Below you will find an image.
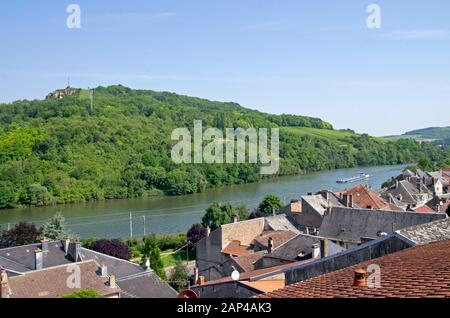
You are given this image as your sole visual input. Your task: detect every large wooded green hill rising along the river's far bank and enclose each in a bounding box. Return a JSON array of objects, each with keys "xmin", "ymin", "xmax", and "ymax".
[{"xmin": 0, "ymin": 86, "xmax": 449, "ymax": 208}]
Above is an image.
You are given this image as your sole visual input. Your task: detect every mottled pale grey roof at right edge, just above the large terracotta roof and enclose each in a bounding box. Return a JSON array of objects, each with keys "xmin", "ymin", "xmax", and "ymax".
[{"xmin": 397, "ymin": 218, "xmax": 450, "ymax": 245}]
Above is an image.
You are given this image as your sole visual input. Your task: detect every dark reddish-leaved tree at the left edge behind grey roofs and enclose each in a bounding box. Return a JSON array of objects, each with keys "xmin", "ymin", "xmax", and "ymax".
[{"xmin": 0, "ymin": 222, "xmax": 42, "ymax": 248}]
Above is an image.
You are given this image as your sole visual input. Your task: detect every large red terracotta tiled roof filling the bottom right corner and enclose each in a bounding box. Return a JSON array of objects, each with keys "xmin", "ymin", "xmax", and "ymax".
[{"xmin": 260, "ymin": 240, "xmax": 450, "ymax": 298}]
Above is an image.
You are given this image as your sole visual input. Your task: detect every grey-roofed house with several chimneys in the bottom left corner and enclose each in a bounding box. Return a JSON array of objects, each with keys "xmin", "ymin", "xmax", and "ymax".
[{"xmin": 0, "ymin": 240, "xmax": 178, "ymax": 298}]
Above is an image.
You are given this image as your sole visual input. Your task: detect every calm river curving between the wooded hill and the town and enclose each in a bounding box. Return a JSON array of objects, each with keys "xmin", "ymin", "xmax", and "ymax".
[{"xmin": 0, "ymin": 165, "xmax": 406, "ymax": 238}]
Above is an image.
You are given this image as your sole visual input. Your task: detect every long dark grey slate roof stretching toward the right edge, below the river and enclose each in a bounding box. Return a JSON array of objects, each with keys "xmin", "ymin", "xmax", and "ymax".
[{"xmin": 319, "ymin": 208, "xmax": 447, "ymax": 244}]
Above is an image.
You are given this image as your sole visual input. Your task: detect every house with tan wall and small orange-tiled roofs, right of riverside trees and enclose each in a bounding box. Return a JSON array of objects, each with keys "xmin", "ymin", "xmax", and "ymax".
[{"xmin": 196, "ymin": 215, "xmax": 299, "ymax": 281}]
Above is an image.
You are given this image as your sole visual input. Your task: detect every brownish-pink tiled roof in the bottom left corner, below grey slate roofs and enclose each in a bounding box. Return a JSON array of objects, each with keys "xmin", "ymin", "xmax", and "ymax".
[{"xmin": 9, "ymin": 261, "xmax": 120, "ymax": 298}]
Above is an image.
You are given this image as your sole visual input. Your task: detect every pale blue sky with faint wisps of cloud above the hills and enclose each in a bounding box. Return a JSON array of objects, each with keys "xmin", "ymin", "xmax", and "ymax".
[{"xmin": 0, "ymin": 0, "xmax": 450, "ymax": 135}]
